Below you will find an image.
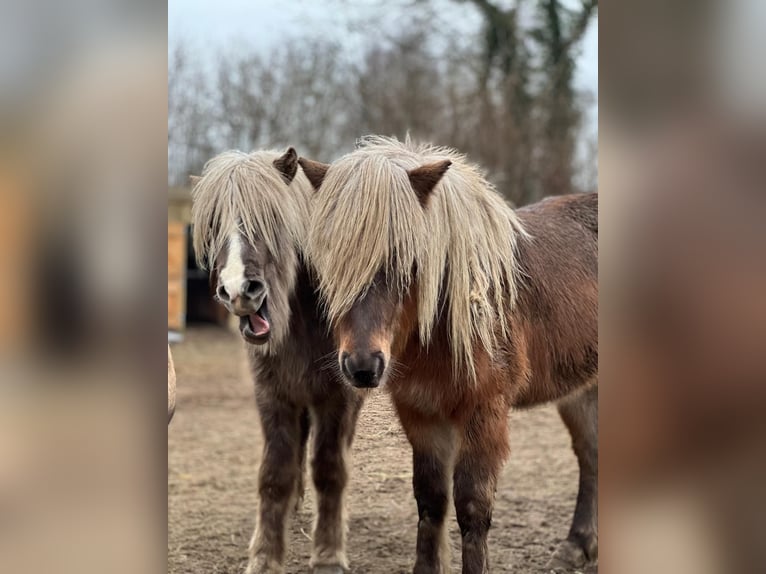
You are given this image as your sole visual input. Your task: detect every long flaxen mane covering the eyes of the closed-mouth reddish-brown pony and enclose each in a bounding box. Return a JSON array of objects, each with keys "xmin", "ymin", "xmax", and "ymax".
[{"xmin": 307, "ymin": 137, "xmax": 526, "ymax": 375}]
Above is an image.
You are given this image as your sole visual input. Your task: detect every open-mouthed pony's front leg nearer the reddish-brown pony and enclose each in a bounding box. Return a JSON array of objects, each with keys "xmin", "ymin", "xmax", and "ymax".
[{"xmin": 310, "ymin": 396, "xmax": 362, "ymax": 574}]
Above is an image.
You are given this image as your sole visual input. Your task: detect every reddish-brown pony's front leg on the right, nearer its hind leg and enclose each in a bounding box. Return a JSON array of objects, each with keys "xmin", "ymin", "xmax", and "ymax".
[{"xmin": 454, "ymin": 402, "xmax": 509, "ymax": 574}]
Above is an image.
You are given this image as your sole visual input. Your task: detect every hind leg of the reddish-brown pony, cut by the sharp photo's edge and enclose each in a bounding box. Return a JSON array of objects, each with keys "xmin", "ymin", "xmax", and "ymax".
[{"xmin": 548, "ymin": 387, "xmax": 598, "ymax": 572}]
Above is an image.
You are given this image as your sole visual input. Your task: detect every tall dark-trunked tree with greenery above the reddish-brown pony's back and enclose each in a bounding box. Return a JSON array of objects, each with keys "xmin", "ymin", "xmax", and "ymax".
[{"xmin": 460, "ymin": 0, "xmax": 597, "ymax": 204}]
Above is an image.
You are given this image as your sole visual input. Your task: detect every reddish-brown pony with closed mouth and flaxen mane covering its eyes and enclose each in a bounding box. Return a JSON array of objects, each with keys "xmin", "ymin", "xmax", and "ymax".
[{"xmin": 299, "ymin": 137, "xmax": 598, "ymax": 574}]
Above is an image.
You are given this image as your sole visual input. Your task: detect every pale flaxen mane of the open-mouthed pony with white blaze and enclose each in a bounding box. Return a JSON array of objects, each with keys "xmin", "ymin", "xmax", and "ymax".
[{"xmin": 192, "ymin": 151, "xmax": 313, "ymax": 268}]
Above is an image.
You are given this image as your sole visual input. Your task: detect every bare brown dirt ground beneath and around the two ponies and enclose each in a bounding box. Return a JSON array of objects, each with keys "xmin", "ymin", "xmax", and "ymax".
[{"xmin": 168, "ymin": 326, "xmax": 597, "ymax": 574}]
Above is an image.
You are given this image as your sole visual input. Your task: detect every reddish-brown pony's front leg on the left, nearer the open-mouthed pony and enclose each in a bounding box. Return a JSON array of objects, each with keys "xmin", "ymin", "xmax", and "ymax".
[{"xmin": 397, "ymin": 405, "xmax": 456, "ymax": 574}]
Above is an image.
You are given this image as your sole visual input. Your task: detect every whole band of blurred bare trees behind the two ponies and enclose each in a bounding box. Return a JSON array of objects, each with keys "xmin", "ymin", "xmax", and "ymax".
[{"xmin": 168, "ymin": 0, "xmax": 597, "ymax": 205}]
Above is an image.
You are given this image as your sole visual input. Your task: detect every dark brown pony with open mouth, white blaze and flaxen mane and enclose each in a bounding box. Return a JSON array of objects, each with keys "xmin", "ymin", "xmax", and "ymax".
[{"xmin": 192, "ymin": 148, "xmax": 362, "ymax": 574}]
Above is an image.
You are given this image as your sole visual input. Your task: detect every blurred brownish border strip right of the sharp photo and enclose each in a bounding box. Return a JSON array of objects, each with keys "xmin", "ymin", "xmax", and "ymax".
[{"xmin": 599, "ymin": 0, "xmax": 766, "ymax": 574}]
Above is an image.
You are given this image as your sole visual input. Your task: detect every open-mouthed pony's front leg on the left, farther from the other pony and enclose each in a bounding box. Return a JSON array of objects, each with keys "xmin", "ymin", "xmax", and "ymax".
[{"xmin": 247, "ymin": 392, "xmax": 301, "ymax": 574}]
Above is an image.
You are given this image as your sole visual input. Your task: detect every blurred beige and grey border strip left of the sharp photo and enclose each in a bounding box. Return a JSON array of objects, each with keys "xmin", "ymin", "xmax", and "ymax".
[{"xmin": 0, "ymin": 0, "xmax": 167, "ymax": 574}]
